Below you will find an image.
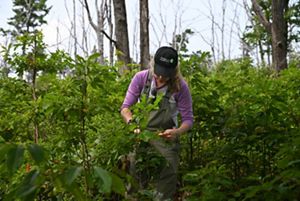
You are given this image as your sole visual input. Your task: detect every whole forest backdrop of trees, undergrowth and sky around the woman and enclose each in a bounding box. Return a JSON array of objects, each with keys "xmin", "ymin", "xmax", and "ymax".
[{"xmin": 0, "ymin": 0, "xmax": 300, "ymax": 200}]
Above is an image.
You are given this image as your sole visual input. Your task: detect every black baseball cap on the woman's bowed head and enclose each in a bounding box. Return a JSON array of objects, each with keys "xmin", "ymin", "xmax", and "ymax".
[{"xmin": 154, "ymin": 46, "xmax": 178, "ymax": 77}]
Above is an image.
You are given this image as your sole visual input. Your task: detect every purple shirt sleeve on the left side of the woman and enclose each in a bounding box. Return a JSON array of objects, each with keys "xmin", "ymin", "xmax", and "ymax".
[{"xmin": 121, "ymin": 71, "xmax": 145, "ymax": 110}]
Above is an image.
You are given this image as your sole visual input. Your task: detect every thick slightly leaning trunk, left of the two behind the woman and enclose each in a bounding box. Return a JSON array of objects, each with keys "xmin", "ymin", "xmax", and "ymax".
[{"xmin": 113, "ymin": 0, "xmax": 130, "ymax": 73}]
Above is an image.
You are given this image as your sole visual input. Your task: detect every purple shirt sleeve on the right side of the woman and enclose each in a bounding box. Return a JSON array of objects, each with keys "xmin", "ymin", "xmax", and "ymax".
[{"xmin": 177, "ymin": 80, "xmax": 194, "ymax": 127}]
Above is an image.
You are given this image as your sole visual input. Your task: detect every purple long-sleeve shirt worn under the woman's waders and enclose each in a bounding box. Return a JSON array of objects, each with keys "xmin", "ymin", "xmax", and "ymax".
[{"xmin": 121, "ymin": 70, "xmax": 194, "ymax": 127}]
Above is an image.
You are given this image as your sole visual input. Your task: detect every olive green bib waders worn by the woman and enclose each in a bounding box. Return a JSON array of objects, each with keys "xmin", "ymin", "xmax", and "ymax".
[{"xmin": 131, "ymin": 72, "xmax": 179, "ymax": 200}]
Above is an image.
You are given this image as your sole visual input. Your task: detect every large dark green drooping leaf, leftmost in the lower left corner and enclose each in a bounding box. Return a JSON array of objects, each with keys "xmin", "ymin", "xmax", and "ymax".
[{"xmin": 6, "ymin": 145, "xmax": 24, "ymax": 174}]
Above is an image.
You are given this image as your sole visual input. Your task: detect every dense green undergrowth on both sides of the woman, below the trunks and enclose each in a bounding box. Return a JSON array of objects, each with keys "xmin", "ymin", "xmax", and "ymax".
[{"xmin": 0, "ymin": 47, "xmax": 300, "ymax": 200}]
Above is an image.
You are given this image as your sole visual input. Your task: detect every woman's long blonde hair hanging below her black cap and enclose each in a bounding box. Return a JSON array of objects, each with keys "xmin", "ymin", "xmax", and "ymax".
[{"xmin": 149, "ymin": 59, "xmax": 182, "ymax": 93}]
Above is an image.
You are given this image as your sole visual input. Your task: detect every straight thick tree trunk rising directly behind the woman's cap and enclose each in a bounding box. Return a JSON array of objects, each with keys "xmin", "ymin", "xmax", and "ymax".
[{"xmin": 140, "ymin": 0, "xmax": 150, "ymax": 70}]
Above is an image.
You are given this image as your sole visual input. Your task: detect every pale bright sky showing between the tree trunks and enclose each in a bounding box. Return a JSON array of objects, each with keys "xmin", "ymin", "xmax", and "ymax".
[{"xmin": 0, "ymin": 0, "xmax": 248, "ymax": 61}]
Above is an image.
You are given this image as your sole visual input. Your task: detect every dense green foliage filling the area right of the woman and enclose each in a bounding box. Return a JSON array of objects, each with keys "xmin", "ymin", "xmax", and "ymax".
[{"xmin": 179, "ymin": 57, "xmax": 300, "ymax": 200}]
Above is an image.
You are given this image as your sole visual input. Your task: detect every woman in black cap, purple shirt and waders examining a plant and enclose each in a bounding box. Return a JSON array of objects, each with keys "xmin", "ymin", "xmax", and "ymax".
[{"xmin": 121, "ymin": 46, "xmax": 193, "ymax": 199}]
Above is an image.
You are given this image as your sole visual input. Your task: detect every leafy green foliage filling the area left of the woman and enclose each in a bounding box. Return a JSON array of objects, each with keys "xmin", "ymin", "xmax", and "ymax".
[{"xmin": 0, "ymin": 51, "xmax": 125, "ymax": 200}]
